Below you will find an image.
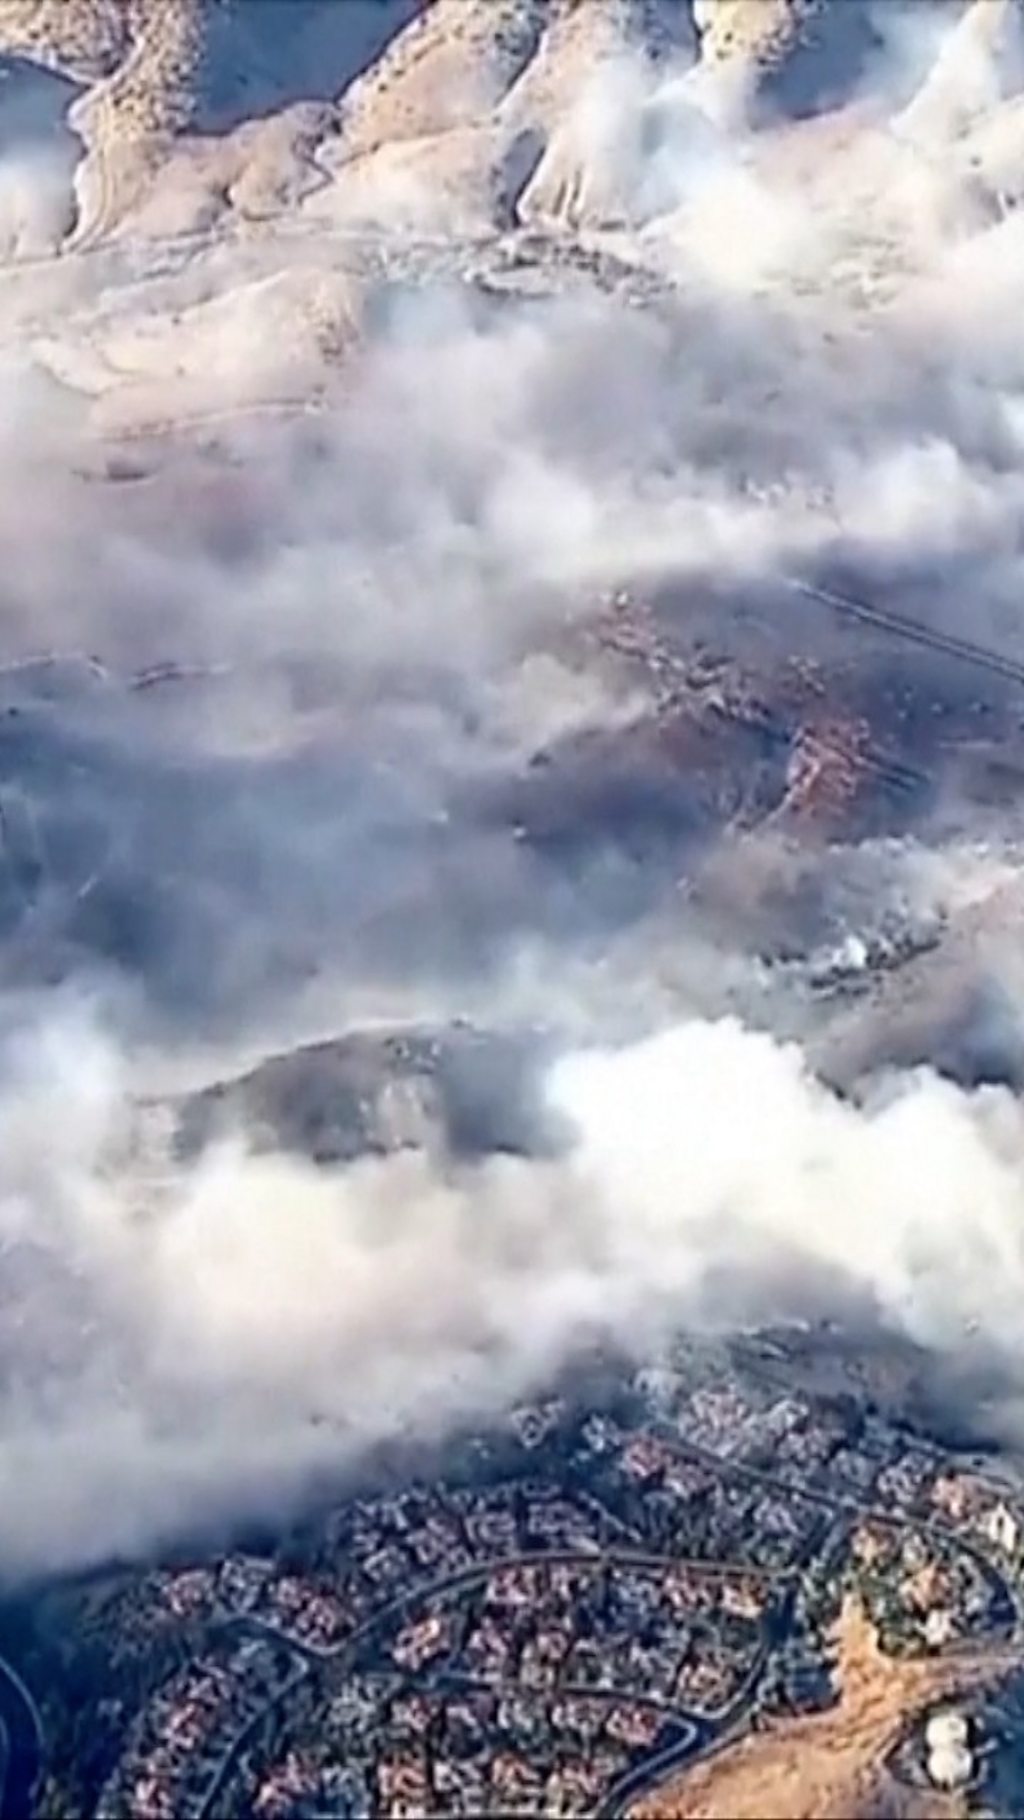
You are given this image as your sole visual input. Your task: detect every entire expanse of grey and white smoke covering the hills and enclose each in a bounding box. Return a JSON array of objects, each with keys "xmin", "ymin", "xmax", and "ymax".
[{"xmin": 0, "ymin": 7, "xmax": 1024, "ymax": 1572}]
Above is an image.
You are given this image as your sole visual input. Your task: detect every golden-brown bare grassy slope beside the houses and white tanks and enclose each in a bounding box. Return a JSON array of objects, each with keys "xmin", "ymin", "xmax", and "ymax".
[{"xmin": 633, "ymin": 1600, "xmax": 1011, "ymax": 1820}]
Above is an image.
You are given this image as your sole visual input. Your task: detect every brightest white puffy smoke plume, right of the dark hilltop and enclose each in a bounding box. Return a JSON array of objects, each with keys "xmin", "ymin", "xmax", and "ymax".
[{"xmin": 553, "ymin": 1023, "xmax": 1024, "ymax": 1347}]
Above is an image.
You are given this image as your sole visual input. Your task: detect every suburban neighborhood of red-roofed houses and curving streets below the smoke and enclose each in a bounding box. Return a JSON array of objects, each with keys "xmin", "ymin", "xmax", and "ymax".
[{"xmin": 6, "ymin": 1343, "xmax": 1024, "ymax": 1820}]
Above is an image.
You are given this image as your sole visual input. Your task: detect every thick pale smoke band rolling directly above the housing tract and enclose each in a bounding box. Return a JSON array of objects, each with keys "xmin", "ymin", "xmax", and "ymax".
[{"xmin": 0, "ymin": 1019, "xmax": 1024, "ymax": 1569}]
